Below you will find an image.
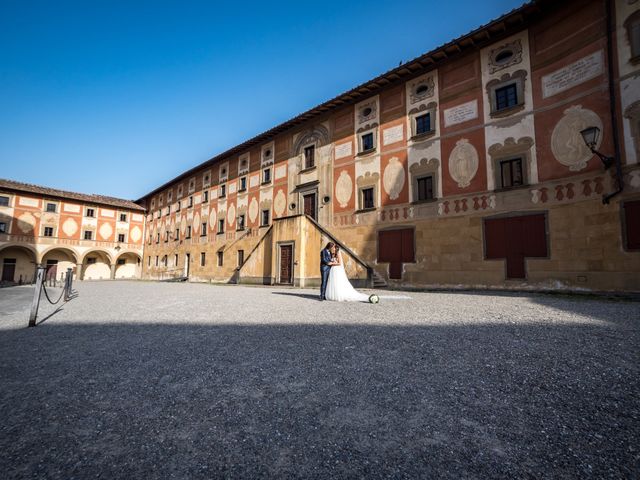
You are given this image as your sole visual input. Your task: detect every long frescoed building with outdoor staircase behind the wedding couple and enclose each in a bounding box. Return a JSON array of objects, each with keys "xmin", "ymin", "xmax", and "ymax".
[{"xmin": 1, "ymin": 0, "xmax": 640, "ymax": 290}]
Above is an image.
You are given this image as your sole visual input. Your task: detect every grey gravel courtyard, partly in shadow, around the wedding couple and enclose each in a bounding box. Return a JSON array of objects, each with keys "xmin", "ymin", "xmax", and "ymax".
[{"xmin": 0, "ymin": 282, "xmax": 640, "ymax": 479}]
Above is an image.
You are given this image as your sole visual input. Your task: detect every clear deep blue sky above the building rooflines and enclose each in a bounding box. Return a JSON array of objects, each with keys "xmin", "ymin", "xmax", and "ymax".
[{"xmin": 0, "ymin": 0, "xmax": 522, "ymax": 199}]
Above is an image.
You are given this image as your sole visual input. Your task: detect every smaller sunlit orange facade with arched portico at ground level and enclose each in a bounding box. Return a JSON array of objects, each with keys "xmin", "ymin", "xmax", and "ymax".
[{"xmin": 0, "ymin": 180, "xmax": 145, "ymax": 283}]
